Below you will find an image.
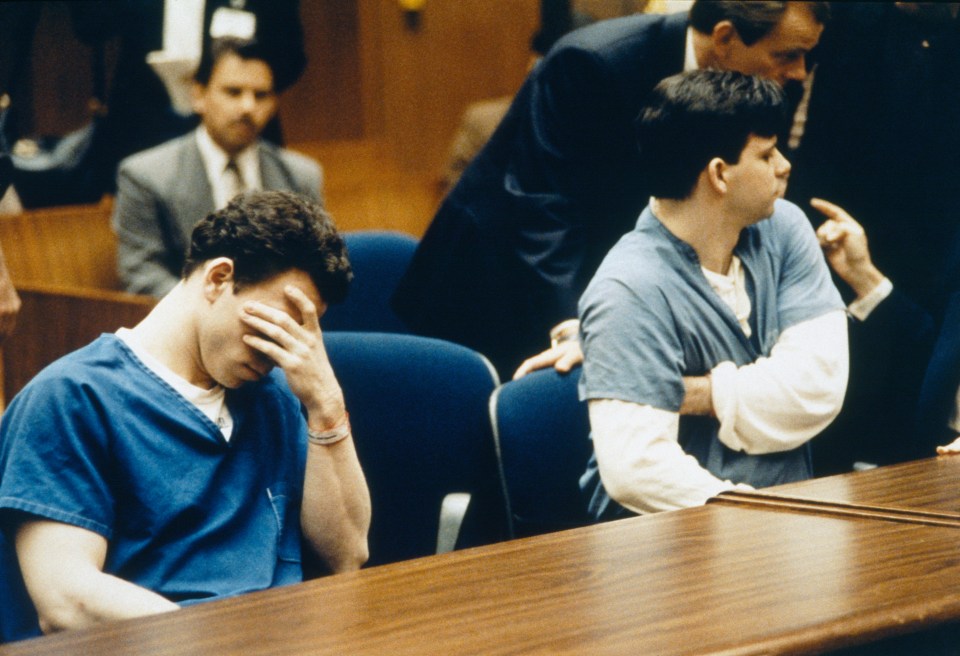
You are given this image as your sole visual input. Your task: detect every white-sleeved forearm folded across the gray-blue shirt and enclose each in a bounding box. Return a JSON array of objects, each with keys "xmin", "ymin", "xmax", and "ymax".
[{"xmin": 711, "ymin": 311, "xmax": 849, "ymax": 454}]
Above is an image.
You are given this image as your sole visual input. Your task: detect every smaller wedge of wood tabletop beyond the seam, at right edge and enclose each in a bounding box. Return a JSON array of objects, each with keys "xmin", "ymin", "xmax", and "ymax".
[{"xmin": 715, "ymin": 456, "xmax": 960, "ymax": 528}]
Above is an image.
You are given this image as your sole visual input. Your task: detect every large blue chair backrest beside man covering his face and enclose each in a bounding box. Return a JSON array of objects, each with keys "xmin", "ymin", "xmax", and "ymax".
[{"xmin": 324, "ymin": 332, "xmax": 507, "ymax": 565}]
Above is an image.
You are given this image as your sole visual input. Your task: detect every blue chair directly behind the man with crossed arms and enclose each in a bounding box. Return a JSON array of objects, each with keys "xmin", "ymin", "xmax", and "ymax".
[{"xmin": 490, "ymin": 368, "xmax": 593, "ymax": 537}]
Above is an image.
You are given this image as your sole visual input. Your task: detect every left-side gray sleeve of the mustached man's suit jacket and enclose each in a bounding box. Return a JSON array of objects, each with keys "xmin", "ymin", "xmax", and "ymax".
[{"xmin": 113, "ymin": 164, "xmax": 180, "ymax": 297}]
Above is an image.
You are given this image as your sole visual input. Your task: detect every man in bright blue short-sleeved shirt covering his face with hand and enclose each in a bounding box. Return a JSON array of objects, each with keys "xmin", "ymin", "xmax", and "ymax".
[{"xmin": 0, "ymin": 192, "xmax": 370, "ymax": 632}]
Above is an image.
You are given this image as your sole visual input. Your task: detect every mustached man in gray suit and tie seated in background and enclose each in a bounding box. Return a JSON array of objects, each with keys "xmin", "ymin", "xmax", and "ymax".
[{"xmin": 113, "ymin": 39, "xmax": 322, "ymax": 297}]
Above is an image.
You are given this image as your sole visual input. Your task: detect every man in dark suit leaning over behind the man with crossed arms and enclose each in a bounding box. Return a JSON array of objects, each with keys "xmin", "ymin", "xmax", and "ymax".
[{"xmin": 394, "ymin": 2, "xmax": 826, "ymax": 376}]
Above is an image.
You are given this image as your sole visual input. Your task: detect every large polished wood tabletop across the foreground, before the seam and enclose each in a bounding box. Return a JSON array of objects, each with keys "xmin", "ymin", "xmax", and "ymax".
[{"xmin": 0, "ymin": 504, "xmax": 960, "ymax": 656}]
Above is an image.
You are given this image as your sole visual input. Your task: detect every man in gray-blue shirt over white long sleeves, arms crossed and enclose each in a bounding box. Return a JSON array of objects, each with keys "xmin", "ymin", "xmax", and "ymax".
[{"xmin": 580, "ymin": 71, "xmax": 847, "ymax": 519}]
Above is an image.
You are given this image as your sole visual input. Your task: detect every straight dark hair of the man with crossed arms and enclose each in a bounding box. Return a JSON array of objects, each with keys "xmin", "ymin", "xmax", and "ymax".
[{"xmin": 636, "ymin": 70, "xmax": 788, "ymax": 200}]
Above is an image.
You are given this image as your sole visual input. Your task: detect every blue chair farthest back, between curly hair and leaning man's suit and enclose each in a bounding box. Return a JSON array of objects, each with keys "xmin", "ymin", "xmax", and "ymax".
[{"xmin": 320, "ymin": 230, "xmax": 417, "ymax": 333}]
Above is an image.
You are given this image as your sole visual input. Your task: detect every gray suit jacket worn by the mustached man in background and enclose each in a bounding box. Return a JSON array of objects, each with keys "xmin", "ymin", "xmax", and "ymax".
[{"xmin": 113, "ymin": 132, "xmax": 323, "ymax": 296}]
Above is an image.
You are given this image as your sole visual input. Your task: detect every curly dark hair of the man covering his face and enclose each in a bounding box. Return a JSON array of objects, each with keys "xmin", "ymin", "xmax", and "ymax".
[{"xmin": 183, "ymin": 191, "xmax": 353, "ymax": 303}]
